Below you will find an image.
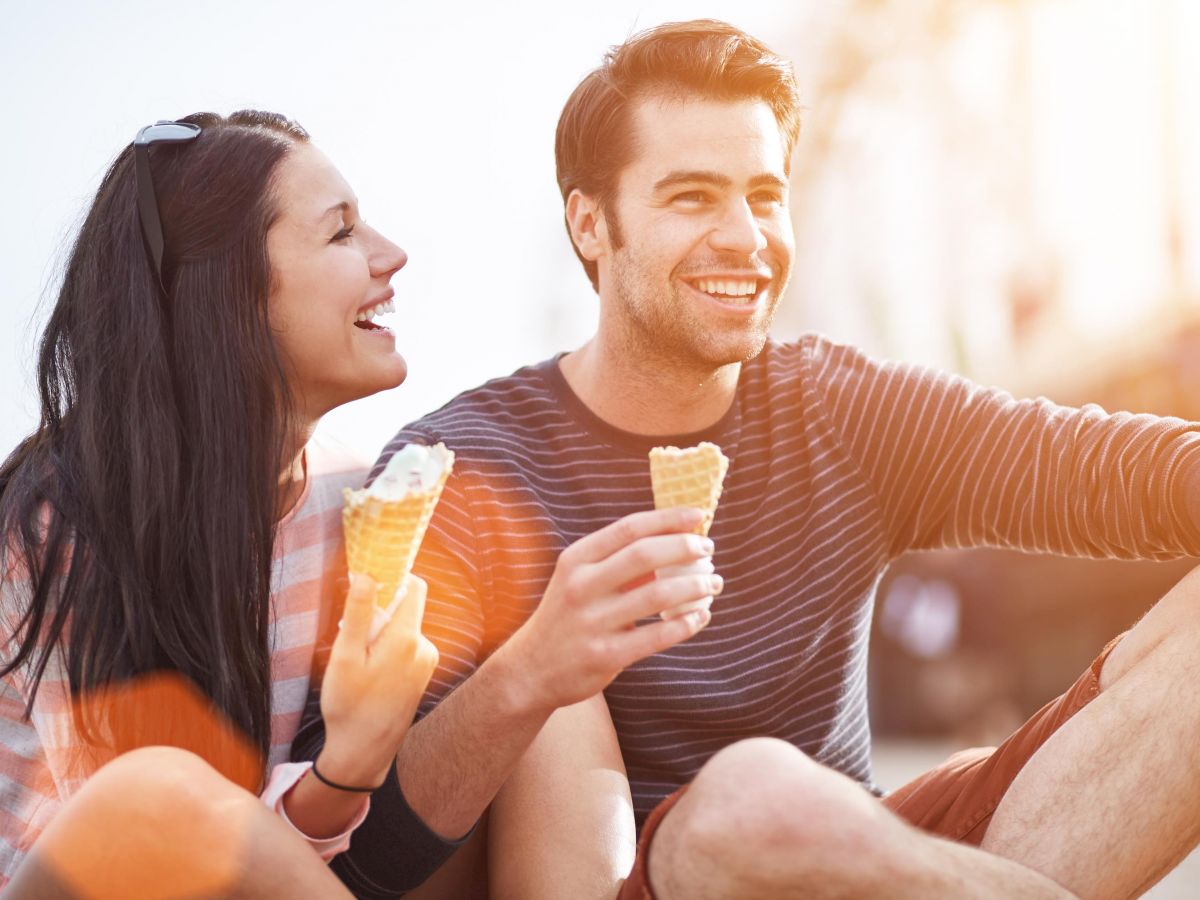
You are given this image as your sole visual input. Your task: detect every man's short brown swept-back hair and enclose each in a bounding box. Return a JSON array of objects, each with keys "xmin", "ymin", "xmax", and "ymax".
[{"xmin": 554, "ymin": 19, "xmax": 800, "ymax": 290}]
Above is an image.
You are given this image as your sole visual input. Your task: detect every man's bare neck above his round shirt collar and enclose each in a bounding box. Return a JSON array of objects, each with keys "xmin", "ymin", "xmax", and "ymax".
[{"xmin": 558, "ymin": 335, "xmax": 742, "ymax": 436}]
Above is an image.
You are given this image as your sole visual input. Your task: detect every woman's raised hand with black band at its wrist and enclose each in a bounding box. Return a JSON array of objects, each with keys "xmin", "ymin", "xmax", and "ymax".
[{"xmin": 317, "ymin": 572, "xmax": 438, "ymax": 787}]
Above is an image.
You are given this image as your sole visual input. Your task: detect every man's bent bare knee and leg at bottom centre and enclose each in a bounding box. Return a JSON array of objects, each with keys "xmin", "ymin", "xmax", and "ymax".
[{"xmin": 649, "ymin": 738, "xmax": 1070, "ymax": 900}]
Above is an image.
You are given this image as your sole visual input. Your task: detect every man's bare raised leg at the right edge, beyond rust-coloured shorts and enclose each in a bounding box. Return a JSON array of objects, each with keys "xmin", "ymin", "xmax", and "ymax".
[{"xmin": 983, "ymin": 570, "xmax": 1200, "ymax": 898}]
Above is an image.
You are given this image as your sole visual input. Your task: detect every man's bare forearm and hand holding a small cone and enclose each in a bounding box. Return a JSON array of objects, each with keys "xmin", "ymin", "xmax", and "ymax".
[{"xmin": 396, "ymin": 510, "xmax": 722, "ymax": 839}]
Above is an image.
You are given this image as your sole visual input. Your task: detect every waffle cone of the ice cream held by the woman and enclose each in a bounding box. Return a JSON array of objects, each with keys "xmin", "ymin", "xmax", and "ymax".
[{"xmin": 342, "ymin": 457, "xmax": 452, "ymax": 608}]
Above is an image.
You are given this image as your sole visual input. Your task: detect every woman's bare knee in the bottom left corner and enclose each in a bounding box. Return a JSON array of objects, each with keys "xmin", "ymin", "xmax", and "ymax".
[{"xmin": 5, "ymin": 748, "xmax": 349, "ymax": 900}]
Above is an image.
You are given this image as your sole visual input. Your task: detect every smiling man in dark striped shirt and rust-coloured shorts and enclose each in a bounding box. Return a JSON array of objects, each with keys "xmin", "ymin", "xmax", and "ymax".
[{"xmin": 297, "ymin": 15, "xmax": 1200, "ymax": 900}]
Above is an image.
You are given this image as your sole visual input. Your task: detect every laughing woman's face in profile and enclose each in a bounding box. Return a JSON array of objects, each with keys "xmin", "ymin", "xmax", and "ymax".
[{"xmin": 266, "ymin": 143, "xmax": 408, "ymax": 421}]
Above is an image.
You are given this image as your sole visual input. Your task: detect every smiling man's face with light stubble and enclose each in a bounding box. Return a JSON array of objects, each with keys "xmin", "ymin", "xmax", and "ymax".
[{"xmin": 598, "ymin": 97, "xmax": 794, "ymax": 367}]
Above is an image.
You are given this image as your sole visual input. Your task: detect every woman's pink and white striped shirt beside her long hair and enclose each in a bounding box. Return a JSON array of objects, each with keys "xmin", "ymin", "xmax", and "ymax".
[{"xmin": 0, "ymin": 439, "xmax": 366, "ymax": 887}]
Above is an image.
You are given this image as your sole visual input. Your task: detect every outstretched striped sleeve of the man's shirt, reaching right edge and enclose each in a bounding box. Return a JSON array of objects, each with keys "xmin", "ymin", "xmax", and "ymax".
[{"xmin": 808, "ymin": 342, "xmax": 1200, "ymax": 559}]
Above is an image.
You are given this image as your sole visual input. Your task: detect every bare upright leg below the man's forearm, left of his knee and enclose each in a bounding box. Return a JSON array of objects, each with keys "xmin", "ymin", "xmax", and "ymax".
[{"xmin": 488, "ymin": 694, "xmax": 637, "ymax": 900}]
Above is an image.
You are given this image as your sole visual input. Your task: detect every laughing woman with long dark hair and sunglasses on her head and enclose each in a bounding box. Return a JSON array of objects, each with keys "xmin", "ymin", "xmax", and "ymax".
[{"xmin": 0, "ymin": 112, "xmax": 436, "ymax": 898}]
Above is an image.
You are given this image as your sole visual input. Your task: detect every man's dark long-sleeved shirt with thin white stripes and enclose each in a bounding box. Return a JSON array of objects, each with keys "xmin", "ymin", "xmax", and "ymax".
[{"xmin": 374, "ymin": 335, "xmax": 1200, "ymax": 827}]
